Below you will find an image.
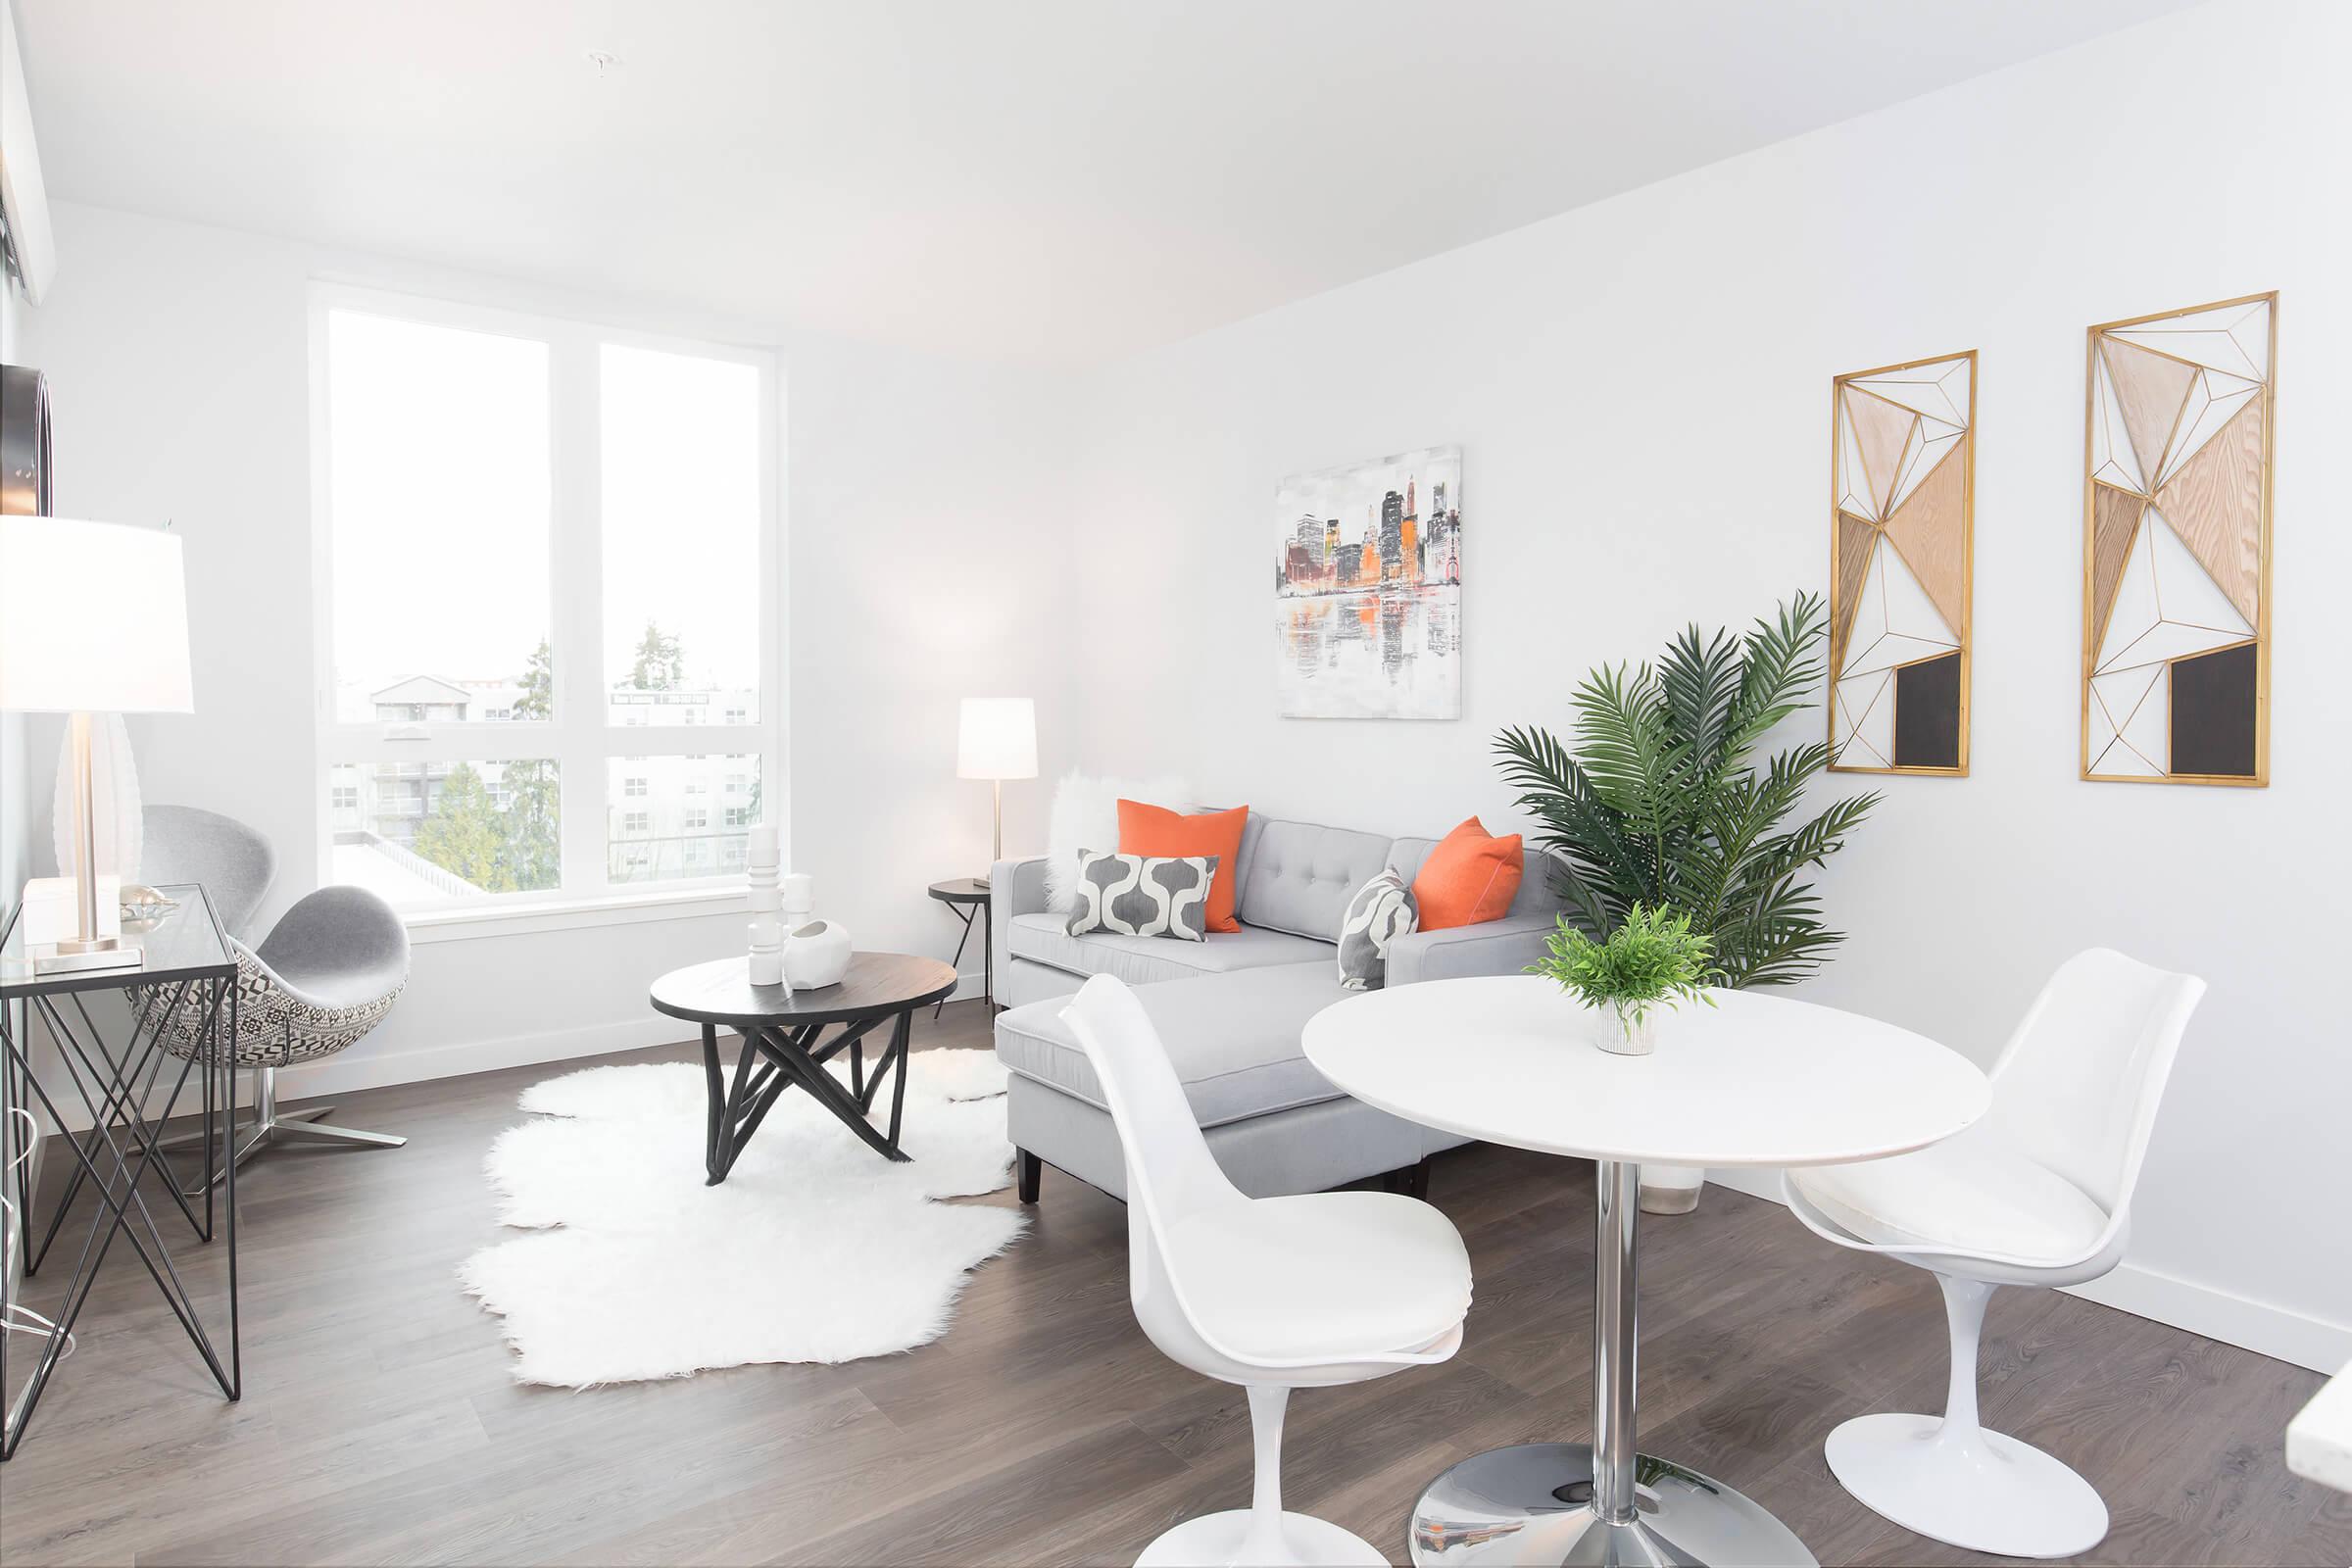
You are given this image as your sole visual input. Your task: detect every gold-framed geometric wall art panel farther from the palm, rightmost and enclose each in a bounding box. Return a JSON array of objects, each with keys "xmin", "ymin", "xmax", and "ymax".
[{"xmin": 2082, "ymin": 294, "xmax": 2279, "ymax": 785}]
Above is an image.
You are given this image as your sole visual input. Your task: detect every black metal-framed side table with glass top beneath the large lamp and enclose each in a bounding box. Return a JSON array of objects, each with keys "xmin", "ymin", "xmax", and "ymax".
[{"xmin": 0, "ymin": 884, "xmax": 245, "ymax": 1460}]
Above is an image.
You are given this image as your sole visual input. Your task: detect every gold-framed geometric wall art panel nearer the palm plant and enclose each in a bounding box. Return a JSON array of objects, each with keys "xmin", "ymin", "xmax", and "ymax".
[{"xmin": 1828, "ymin": 348, "xmax": 1976, "ymax": 778}]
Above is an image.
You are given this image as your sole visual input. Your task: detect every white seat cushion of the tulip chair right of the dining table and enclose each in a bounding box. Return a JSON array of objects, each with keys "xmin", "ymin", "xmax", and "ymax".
[{"xmin": 1788, "ymin": 1124, "xmax": 2107, "ymax": 1265}]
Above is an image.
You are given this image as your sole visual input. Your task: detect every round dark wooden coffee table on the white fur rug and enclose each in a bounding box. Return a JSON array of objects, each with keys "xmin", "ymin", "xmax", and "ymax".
[{"xmin": 654, "ymin": 953, "xmax": 955, "ymax": 1187}]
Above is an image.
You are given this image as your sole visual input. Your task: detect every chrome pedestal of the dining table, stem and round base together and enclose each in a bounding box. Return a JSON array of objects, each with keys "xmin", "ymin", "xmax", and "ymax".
[{"xmin": 1411, "ymin": 1159, "xmax": 1816, "ymax": 1568}]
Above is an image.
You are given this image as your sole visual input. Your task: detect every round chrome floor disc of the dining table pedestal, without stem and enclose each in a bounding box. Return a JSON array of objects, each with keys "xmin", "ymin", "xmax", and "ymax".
[{"xmin": 1411, "ymin": 1444, "xmax": 1813, "ymax": 1568}]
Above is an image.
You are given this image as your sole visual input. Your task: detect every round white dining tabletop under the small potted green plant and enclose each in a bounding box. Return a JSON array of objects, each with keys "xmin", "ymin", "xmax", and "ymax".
[{"xmin": 1303, "ymin": 976, "xmax": 1992, "ymax": 1166}]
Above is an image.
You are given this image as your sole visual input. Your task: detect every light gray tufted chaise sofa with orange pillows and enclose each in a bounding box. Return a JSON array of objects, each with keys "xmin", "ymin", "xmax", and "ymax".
[{"xmin": 990, "ymin": 815, "xmax": 1559, "ymax": 1201}]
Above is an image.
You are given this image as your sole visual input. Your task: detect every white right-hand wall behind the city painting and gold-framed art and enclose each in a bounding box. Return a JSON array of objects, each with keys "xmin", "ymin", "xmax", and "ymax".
[{"xmin": 1075, "ymin": 0, "xmax": 2352, "ymax": 1366}]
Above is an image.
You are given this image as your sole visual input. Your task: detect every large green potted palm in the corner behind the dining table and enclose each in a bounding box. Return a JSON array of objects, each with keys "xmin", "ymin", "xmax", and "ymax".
[{"xmin": 1495, "ymin": 592, "xmax": 1880, "ymax": 1213}]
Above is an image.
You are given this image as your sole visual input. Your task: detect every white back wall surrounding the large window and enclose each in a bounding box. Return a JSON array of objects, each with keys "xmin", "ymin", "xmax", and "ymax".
[{"xmin": 24, "ymin": 202, "xmax": 1070, "ymax": 1091}]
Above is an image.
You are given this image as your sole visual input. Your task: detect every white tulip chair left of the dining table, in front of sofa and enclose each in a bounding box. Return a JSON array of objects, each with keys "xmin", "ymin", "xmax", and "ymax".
[{"xmin": 1065, "ymin": 976, "xmax": 1470, "ymax": 1568}]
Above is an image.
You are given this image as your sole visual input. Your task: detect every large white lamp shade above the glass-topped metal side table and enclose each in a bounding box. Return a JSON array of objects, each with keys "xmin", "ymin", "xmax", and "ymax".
[{"xmin": 0, "ymin": 514, "xmax": 195, "ymax": 712}]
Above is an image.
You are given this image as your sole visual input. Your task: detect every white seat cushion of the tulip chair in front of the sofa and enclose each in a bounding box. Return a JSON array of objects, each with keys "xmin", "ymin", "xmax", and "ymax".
[{"xmin": 1159, "ymin": 1192, "xmax": 1470, "ymax": 1361}]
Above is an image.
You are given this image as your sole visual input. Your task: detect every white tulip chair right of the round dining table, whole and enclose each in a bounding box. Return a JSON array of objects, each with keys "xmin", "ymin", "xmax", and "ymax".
[{"xmin": 1783, "ymin": 948, "xmax": 2206, "ymax": 1556}]
